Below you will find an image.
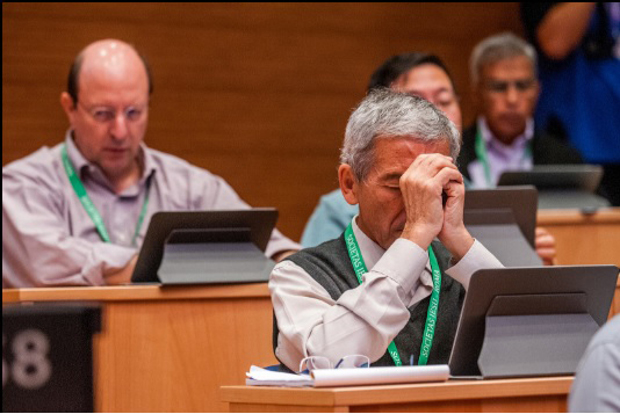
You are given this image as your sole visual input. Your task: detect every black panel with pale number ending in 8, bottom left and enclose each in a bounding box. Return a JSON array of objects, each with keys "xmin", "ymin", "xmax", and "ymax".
[{"xmin": 2, "ymin": 304, "xmax": 101, "ymax": 412}]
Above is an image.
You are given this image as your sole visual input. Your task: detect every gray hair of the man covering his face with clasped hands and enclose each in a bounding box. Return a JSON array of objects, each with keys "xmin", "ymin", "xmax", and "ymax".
[{"xmin": 340, "ymin": 88, "xmax": 461, "ymax": 181}]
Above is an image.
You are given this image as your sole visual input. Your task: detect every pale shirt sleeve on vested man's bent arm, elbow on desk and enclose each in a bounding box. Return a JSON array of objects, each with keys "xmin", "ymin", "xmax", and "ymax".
[{"xmin": 269, "ymin": 239, "xmax": 427, "ymax": 371}]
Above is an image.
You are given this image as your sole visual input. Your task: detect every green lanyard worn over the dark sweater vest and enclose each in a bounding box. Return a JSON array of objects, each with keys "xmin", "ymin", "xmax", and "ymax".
[{"xmin": 344, "ymin": 223, "xmax": 441, "ymax": 367}]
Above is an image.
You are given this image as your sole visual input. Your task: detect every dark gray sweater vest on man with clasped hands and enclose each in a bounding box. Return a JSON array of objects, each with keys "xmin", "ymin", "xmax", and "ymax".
[{"xmin": 273, "ymin": 235, "xmax": 465, "ymax": 366}]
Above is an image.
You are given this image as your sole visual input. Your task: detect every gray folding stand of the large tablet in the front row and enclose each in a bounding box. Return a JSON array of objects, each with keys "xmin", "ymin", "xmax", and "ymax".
[{"xmin": 478, "ymin": 293, "xmax": 599, "ymax": 378}]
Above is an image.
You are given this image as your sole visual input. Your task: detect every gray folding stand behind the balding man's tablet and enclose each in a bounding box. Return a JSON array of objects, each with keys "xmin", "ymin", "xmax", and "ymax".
[{"xmin": 157, "ymin": 227, "xmax": 275, "ymax": 285}]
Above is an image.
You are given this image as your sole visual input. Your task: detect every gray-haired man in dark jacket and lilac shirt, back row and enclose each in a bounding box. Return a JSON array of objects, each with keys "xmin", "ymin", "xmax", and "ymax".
[{"xmin": 458, "ymin": 33, "xmax": 582, "ymax": 191}]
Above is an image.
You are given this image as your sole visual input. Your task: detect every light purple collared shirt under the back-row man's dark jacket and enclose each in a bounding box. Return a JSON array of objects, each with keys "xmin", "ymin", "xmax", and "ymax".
[{"xmin": 467, "ymin": 117, "xmax": 534, "ymax": 188}]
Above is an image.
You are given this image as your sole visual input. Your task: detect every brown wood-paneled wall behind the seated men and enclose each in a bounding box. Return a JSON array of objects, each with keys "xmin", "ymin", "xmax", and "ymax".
[{"xmin": 2, "ymin": 3, "xmax": 522, "ymax": 239}]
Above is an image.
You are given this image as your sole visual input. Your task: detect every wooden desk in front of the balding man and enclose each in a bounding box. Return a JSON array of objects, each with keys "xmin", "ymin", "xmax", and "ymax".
[{"xmin": 2, "ymin": 284, "xmax": 276, "ymax": 412}]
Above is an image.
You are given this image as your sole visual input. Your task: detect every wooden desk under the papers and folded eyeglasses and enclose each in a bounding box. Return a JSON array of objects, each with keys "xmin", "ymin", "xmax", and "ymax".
[{"xmin": 220, "ymin": 377, "xmax": 573, "ymax": 412}]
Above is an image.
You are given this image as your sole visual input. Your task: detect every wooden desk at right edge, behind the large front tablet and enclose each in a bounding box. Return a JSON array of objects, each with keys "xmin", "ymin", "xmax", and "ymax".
[{"xmin": 537, "ymin": 208, "xmax": 620, "ymax": 315}]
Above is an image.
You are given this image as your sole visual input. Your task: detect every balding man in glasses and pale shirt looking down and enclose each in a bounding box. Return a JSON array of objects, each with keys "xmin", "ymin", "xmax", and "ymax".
[{"xmin": 2, "ymin": 39, "xmax": 298, "ymax": 287}]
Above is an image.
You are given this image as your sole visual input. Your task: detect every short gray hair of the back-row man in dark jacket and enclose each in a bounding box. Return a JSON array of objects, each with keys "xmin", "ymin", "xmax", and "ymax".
[{"xmin": 469, "ymin": 32, "xmax": 538, "ymax": 85}]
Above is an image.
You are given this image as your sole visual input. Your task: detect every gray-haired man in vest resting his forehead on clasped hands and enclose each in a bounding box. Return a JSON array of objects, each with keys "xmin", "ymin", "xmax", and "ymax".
[{"xmin": 269, "ymin": 89, "xmax": 501, "ymax": 371}]
